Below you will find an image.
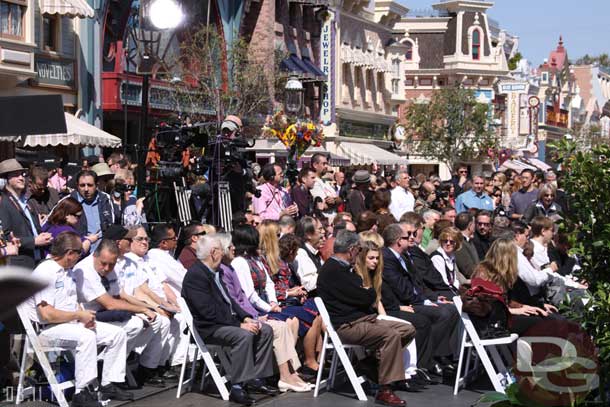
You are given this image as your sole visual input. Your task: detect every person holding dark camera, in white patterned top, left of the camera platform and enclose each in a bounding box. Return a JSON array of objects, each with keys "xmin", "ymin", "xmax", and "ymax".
[{"xmin": 107, "ymin": 169, "xmax": 146, "ymax": 226}]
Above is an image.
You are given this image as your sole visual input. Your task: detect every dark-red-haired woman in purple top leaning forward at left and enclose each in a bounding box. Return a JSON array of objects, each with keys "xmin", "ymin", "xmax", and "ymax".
[{"xmin": 42, "ymin": 197, "xmax": 99, "ymax": 253}]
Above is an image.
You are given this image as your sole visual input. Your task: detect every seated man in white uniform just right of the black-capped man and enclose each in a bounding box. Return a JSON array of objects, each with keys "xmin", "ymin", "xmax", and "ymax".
[{"xmin": 125, "ymin": 226, "xmax": 181, "ymax": 380}]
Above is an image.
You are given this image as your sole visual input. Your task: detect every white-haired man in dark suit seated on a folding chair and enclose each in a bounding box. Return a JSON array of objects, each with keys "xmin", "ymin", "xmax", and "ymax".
[{"xmin": 182, "ymin": 235, "xmax": 277, "ymax": 405}]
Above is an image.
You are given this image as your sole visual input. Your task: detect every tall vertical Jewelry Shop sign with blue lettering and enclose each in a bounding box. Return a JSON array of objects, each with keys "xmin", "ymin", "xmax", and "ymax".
[{"xmin": 320, "ymin": 10, "xmax": 334, "ymax": 125}]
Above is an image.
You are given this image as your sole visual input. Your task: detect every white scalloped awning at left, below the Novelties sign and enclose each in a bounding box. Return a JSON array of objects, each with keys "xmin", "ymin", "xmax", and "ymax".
[{"xmin": 12, "ymin": 113, "xmax": 121, "ymax": 147}]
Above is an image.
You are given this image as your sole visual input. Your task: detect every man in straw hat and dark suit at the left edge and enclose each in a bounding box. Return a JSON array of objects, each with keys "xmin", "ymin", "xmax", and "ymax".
[{"xmin": 0, "ymin": 158, "xmax": 53, "ymax": 269}]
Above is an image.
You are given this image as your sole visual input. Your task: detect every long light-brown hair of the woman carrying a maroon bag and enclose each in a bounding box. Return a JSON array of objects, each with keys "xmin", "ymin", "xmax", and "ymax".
[{"xmin": 474, "ymin": 237, "xmax": 519, "ymax": 291}]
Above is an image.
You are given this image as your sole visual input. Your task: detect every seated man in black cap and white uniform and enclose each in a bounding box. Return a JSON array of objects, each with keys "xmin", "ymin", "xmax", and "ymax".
[{"xmin": 104, "ymin": 225, "xmax": 170, "ymax": 386}]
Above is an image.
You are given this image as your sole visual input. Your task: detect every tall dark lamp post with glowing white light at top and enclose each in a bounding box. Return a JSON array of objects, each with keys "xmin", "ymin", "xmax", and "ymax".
[{"xmin": 137, "ymin": 0, "xmax": 184, "ymax": 197}]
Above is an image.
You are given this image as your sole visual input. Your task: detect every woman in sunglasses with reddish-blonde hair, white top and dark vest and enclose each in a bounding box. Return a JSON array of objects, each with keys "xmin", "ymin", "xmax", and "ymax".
[{"xmin": 430, "ymin": 226, "xmax": 465, "ymax": 298}]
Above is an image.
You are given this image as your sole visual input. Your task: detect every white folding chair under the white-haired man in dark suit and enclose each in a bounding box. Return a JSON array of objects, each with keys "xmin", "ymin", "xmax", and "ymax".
[{"xmin": 176, "ymin": 297, "xmax": 229, "ymax": 401}]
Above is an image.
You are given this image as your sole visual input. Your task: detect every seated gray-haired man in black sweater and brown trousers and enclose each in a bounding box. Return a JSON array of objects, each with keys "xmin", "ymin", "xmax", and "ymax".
[{"xmin": 317, "ymin": 230, "xmax": 415, "ymax": 406}]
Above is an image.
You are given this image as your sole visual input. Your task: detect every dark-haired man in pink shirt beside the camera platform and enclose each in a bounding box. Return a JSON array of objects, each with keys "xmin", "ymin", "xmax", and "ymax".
[{"xmin": 252, "ymin": 164, "xmax": 299, "ymax": 221}]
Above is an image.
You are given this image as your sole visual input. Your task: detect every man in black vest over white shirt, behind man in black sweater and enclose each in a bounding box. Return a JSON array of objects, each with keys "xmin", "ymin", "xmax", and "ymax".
[{"xmin": 295, "ymin": 216, "xmax": 326, "ymax": 292}]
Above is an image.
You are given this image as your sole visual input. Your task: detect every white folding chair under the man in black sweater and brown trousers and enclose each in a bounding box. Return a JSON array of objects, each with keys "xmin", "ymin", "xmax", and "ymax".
[{"xmin": 313, "ymin": 297, "xmax": 367, "ymax": 401}]
